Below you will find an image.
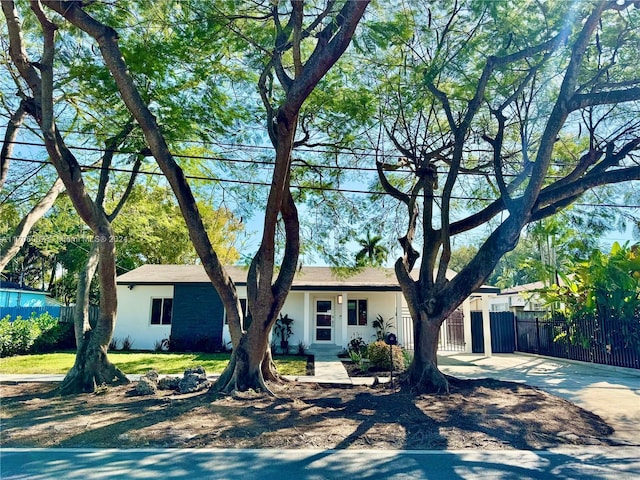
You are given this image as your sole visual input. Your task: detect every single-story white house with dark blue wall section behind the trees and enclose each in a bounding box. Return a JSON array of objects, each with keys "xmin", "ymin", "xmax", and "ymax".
[{"xmin": 114, "ymin": 265, "xmax": 498, "ymax": 351}]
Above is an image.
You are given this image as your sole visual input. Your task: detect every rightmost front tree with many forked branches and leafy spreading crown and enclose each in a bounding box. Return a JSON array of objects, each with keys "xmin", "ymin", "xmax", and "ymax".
[{"xmin": 371, "ymin": 1, "xmax": 640, "ymax": 391}]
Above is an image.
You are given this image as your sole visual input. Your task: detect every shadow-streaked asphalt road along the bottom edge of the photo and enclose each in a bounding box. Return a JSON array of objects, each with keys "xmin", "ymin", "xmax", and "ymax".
[{"xmin": 0, "ymin": 447, "xmax": 640, "ymax": 480}]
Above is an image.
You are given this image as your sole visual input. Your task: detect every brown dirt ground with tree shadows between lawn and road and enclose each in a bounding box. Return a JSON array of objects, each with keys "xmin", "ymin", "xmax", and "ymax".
[{"xmin": 0, "ymin": 380, "xmax": 612, "ymax": 449}]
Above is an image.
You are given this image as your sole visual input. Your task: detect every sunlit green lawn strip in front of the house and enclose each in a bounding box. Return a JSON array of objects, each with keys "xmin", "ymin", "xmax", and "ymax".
[{"xmin": 0, "ymin": 352, "xmax": 307, "ymax": 375}]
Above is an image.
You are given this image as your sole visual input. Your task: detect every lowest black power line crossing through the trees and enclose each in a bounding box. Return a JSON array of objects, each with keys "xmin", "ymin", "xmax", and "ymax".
[{"xmin": 7, "ymin": 157, "xmax": 640, "ymax": 209}]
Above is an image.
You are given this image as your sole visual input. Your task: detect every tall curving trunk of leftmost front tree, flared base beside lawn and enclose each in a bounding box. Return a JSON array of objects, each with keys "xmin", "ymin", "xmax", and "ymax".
[{"xmin": 2, "ymin": 1, "xmax": 129, "ymax": 394}]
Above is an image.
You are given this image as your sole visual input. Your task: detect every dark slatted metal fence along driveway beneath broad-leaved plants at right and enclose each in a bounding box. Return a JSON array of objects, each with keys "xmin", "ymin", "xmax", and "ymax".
[{"xmin": 516, "ymin": 314, "xmax": 640, "ymax": 369}]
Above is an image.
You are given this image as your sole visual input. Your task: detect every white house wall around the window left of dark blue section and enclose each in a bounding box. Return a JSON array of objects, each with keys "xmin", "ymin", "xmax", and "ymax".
[{"xmin": 113, "ymin": 285, "xmax": 173, "ymax": 350}]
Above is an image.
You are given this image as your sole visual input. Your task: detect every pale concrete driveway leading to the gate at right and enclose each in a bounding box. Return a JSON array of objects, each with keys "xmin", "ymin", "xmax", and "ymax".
[{"xmin": 439, "ymin": 354, "xmax": 640, "ymax": 445}]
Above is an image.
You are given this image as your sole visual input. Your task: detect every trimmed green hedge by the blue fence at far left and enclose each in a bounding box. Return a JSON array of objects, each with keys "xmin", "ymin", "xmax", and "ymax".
[{"xmin": 0, "ymin": 312, "xmax": 75, "ymax": 357}]
